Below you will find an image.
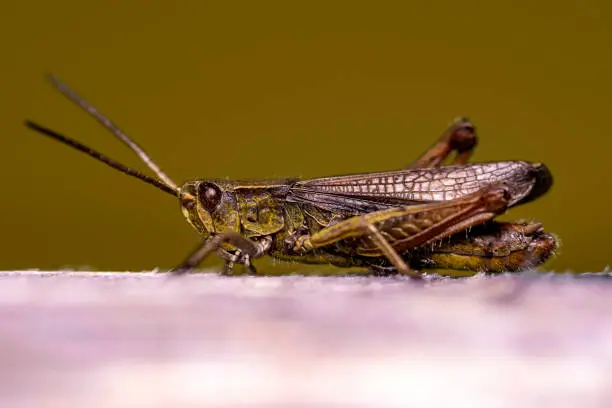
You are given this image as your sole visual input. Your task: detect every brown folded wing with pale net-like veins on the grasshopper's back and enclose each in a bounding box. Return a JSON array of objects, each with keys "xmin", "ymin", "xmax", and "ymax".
[{"xmin": 287, "ymin": 161, "xmax": 550, "ymax": 215}]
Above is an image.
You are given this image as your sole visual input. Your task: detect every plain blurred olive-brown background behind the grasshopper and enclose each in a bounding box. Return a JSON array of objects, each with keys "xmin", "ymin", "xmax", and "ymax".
[{"xmin": 0, "ymin": 0, "xmax": 612, "ymax": 271}]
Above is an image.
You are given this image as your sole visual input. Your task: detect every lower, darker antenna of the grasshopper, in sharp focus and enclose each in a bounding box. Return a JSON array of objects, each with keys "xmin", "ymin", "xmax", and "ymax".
[{"xmin": 25, "ymin": 120, "xmax": 180, "ymax": 197}]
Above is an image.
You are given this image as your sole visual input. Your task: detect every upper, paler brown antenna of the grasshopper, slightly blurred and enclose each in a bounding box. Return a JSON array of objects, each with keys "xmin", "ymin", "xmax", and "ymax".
[{"xmin": 47, "ymin": 74, "xmax": 178, "ymax": 190}]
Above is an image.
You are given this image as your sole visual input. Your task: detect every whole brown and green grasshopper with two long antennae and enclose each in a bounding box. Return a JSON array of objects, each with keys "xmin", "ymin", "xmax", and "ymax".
[{"xmin": 25, "ymin": 76, "xmax": 557, "ymax": 278}]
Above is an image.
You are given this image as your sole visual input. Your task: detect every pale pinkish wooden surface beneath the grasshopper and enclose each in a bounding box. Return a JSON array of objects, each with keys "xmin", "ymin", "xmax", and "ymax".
[{"xmin": 0, "ymin": 272, "xmax": 612, "ymax": 408}]
